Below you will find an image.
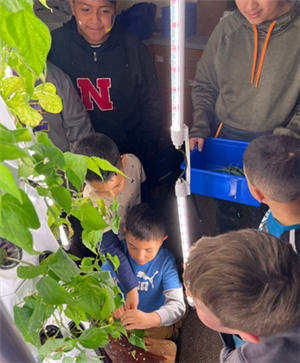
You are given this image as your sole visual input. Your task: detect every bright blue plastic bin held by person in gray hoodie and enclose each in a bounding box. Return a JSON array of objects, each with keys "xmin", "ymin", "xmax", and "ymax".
[{"xmin": 181, "ymin": 138, "xmax": 260, "ymax": 207}]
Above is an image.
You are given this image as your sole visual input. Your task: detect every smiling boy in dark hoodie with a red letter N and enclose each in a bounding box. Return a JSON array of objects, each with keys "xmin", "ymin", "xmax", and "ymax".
[{"xmin": 48, "ymin": 0, "xmax": 162, "ymax": 168}]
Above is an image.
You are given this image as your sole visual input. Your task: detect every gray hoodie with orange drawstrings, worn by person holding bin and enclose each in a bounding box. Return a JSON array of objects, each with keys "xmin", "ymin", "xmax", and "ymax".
[{"xmin": 190, "ymin": 0, "xmax": 300, "ymax": 139}]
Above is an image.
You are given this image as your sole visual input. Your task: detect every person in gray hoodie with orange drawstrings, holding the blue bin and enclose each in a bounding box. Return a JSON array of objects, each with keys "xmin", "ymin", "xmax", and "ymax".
[{"xmin": 190, "ymin": 0, "xmax": 300, "ymax": 233}]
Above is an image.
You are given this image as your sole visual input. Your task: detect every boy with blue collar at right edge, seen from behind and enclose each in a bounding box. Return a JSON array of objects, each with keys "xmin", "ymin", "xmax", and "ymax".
[{"xmin": 244, "ymin": 135, "xmax": 300, "ymax": 253}]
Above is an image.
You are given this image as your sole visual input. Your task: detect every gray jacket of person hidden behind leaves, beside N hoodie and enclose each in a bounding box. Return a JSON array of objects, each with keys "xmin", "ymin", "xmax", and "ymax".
[{"xmin": 30, "ymin": 62, "xmax": 94, "ymax": 152}]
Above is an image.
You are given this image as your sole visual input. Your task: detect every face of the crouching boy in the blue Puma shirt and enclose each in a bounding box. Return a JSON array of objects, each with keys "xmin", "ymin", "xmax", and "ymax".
[{"xmin": 126, "ymin": 232, "xmax": 168, "ymax": 265}]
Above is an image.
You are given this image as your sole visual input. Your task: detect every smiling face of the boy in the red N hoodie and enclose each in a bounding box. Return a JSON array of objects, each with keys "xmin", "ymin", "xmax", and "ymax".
[{"xmin": 69, "ymin": 0, "xmax": 117, "ymax": 44}]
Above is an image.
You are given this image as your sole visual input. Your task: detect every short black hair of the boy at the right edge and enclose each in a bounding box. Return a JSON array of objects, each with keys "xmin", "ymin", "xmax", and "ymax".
[{"xmin": 244, "ymin": 135, "xmax": 300, "ymax": 203}]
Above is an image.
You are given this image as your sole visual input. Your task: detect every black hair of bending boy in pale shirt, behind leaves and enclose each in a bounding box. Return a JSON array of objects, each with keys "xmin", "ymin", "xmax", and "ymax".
[{"xmin": 72, "ymin": 133, "xmax": 122, "ymax": 182}]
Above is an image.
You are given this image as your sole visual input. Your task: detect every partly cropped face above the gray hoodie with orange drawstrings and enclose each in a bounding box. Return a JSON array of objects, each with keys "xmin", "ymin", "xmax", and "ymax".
[{"xmin": 235, "ymin": 0, "xmax": 290, "ymax": 25}]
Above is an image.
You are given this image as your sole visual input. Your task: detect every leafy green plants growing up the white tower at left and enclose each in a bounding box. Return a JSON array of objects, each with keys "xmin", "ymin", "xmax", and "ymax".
[{"xmin": 0, "ymin": 0, "xmax": 145, "ymax": 363}]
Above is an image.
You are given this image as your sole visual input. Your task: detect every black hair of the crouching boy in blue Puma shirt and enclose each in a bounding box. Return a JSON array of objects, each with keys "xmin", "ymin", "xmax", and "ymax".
[{"xmin": 125, "ymin": 203, "xmax": 167, "ymax": 241}]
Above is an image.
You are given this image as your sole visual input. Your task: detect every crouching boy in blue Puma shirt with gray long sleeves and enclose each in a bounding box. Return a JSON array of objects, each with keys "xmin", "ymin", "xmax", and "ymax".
[{"xmin": 102, "ymin": 204, "xmax": 186, "ymax": 340}]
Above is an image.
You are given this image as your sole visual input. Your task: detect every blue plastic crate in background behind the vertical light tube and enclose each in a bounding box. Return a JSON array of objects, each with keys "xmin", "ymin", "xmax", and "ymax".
[{"xmin": 161, "ymin": 3, "xmax": 197, "ymax": 37}]
